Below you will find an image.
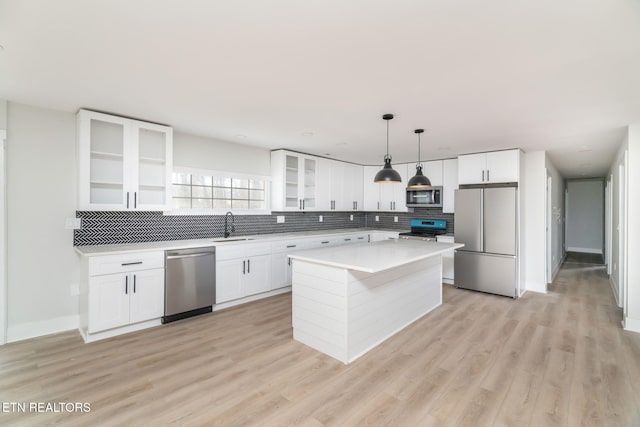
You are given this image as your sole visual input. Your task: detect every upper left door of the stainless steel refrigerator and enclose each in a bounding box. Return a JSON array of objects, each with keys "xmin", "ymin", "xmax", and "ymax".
[{"xmin": 454, "ymin": 188, "xmax": 482, "ymax": 252}]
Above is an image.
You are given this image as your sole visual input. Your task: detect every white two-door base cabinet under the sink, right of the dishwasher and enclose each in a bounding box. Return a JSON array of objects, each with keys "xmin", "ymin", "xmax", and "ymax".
[{"xmin": 216, "ymin": 243, "xmax": 271, "ymax": 304}]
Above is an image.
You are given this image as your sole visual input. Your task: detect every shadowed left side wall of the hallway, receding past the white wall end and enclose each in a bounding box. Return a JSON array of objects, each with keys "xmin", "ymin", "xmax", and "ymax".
[{"xmin": 545, "ymin": 156, "xmax": 565, "ymax": 276}]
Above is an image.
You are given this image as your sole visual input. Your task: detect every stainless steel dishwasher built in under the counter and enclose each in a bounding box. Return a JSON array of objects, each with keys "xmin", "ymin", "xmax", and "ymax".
[{"xmin": 162, "ymin": 246, "xmax": 216, "ymax": 323}]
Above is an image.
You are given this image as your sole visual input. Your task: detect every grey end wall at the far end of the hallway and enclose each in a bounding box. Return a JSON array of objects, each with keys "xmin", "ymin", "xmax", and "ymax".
[{"xmin": 566, "ymin": 179, "xmax": 604, "ymax": 254}]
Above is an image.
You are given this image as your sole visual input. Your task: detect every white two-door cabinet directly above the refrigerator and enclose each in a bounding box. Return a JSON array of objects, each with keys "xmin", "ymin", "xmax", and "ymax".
[{"xmin": 458, "ymin": 149, "xmax": 520, "ymax": 185}]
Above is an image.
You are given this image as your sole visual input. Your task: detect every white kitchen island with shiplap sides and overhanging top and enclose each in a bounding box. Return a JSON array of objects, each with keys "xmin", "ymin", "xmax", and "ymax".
[{"xmin": 289, "ymin": 239, "xmax": 464, "ymax": 363}]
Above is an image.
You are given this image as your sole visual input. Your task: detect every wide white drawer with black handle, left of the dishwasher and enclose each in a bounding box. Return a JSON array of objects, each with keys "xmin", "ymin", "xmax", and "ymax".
[{"xmin": 89, "ymin": 251, "xmax": 164, "ymax": 276}]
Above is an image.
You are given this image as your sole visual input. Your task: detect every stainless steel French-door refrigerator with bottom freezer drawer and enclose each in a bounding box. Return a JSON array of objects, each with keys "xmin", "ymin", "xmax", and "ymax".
[{"xmin": 454, "ymin": 187, "xmax": 518, "ymax": 298}]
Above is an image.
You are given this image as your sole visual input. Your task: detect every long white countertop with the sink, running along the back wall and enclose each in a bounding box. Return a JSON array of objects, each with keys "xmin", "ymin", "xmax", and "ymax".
[{"xmin": 74, "ymin": 228, "xmax": 398, "ymax": 256}]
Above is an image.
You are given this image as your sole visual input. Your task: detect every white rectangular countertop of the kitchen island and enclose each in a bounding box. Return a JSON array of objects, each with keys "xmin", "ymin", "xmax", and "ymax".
[{"xmin": 288, "ymin": 239, "xmax": 464, "ymax": 273}]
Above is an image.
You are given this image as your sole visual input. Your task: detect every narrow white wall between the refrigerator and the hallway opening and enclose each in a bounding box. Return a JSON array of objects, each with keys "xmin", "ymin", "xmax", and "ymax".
[{"xmin": 520, "ymin": 151, "xmax": 547, "ymax": 293}]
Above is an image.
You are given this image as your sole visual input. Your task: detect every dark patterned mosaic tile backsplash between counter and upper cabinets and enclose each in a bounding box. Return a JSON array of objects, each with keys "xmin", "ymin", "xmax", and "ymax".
[{"xmin": 73, "ymin": 208, "xmax": 453, "ymax": 246}]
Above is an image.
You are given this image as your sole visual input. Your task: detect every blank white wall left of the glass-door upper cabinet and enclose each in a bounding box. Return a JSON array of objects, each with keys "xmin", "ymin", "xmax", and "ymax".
[{"xmin": 7, "ymin": 102, "xmax": 78, "ymax": 341}]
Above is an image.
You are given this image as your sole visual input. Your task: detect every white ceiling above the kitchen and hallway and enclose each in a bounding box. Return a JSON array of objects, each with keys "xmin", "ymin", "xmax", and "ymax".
[{"xmin": 0, "ymin": 0, "xmax": 640, "ymax": 178}]
